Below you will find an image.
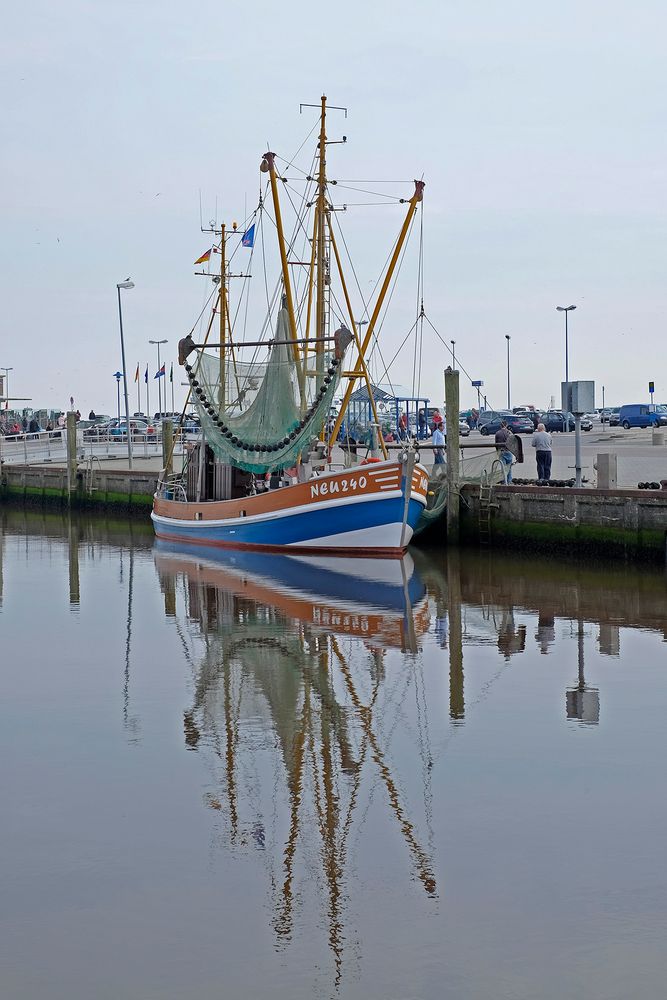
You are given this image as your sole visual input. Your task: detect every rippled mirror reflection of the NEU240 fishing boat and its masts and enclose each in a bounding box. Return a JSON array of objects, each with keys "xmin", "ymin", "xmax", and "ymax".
[{"xmin": 155, "ymin": 541, "xmax": 437, "ymax": 980}]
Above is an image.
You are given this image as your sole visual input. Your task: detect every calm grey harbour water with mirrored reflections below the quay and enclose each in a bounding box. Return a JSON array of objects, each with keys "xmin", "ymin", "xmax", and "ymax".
[{"xmin": 0, "ymin": 511, "xmax": 667, "ymax": 1000}]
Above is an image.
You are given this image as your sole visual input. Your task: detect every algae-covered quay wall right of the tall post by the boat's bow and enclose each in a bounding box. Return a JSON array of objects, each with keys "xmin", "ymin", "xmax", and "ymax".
[{"xmin": 461, "ymin": 486, "xmax": 667, "ymax": 563}]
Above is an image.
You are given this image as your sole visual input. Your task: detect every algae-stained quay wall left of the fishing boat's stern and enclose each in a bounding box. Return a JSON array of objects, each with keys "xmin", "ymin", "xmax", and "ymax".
[{"xmin": 0, "ymin": 465, "xmax": 158, "ymax": 517}]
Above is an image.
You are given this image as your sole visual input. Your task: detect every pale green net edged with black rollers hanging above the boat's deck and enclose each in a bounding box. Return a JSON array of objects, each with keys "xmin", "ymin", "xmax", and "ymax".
[{"xmin": 185, "ymin": 307, "xmax": 352, "ymax": 473}]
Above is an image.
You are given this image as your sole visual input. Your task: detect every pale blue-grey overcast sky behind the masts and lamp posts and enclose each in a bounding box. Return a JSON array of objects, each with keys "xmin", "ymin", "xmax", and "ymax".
[{"xmin": 0, "ymin": 0, "xmax": 667, "ymax": 415}]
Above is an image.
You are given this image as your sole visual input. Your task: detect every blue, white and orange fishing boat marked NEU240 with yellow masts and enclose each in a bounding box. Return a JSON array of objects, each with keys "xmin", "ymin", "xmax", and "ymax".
[{"xmin": 152, "ymin": 97, "xmax": 429, "ymax": 556}]
